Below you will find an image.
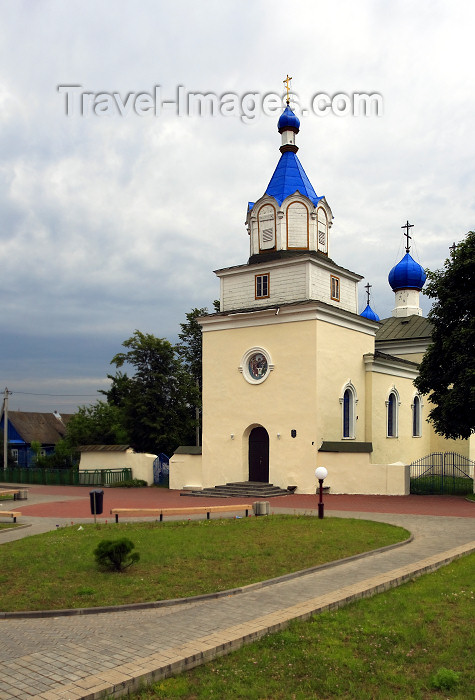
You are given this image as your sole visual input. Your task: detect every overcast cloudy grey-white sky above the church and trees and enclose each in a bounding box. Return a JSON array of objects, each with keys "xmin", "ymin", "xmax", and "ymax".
[{"xmin": 0, "ymin": 0, "xmax": 475, "ymax": 412}]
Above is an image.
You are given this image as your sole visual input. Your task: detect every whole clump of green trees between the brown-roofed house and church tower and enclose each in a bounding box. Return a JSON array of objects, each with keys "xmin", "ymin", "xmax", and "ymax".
[{"xmin": 66, "ymin": 301, "xmax": 219, "ymax": 455}]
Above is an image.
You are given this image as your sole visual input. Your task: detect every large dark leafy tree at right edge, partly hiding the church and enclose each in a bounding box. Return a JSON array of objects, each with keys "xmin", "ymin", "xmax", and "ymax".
[{"xmin": 414, "ymin": 231, "xmax": 475, "ymax": 439}]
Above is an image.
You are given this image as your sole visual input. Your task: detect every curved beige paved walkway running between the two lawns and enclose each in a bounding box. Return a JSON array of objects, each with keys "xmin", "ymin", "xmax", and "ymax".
[{"xmin": 0, "ymin": 490, "xmax": 475, "ymax": 700}]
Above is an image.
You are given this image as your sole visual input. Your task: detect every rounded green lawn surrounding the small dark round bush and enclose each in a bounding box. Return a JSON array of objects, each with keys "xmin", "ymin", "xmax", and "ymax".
[{"xmin": 0, "ymin": 515, "xmax": 408, "ymax": 611}]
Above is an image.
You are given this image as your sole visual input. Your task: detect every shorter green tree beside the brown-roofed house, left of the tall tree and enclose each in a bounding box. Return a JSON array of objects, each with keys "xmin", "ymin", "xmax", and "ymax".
[{"xmin": 66, "ymin": 401, "xmax": 129, "ymax": 448}]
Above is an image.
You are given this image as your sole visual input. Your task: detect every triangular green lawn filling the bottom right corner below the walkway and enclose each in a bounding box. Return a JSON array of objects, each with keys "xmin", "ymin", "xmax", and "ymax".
[{"xmin": 132, "ymin": 555, "xmax": 475, "ymax": 700}]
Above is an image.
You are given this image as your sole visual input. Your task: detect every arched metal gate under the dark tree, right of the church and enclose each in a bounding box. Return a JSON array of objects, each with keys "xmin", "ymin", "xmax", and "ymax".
[{"xmin": 410, "ymin": 452, "xmax": 475, "ymax": 494}]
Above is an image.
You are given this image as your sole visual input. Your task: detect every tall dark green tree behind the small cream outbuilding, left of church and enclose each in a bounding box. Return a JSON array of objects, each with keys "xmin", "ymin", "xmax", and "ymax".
[{"xmin": 105, "ymin": 330, "xmax": 197, "ymax": 454}]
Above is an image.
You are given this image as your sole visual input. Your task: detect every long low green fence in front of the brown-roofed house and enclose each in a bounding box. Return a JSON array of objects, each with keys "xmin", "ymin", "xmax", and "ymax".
[{"xmin": 0, "ymin": 467, "xmax": 132, "ymax": 486}]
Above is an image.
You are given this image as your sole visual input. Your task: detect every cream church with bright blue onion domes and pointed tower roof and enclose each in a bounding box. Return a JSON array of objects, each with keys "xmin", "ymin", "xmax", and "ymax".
[{"xmin": 170, "ymin": 95, "xmax": 475, "ymax": 495}]
